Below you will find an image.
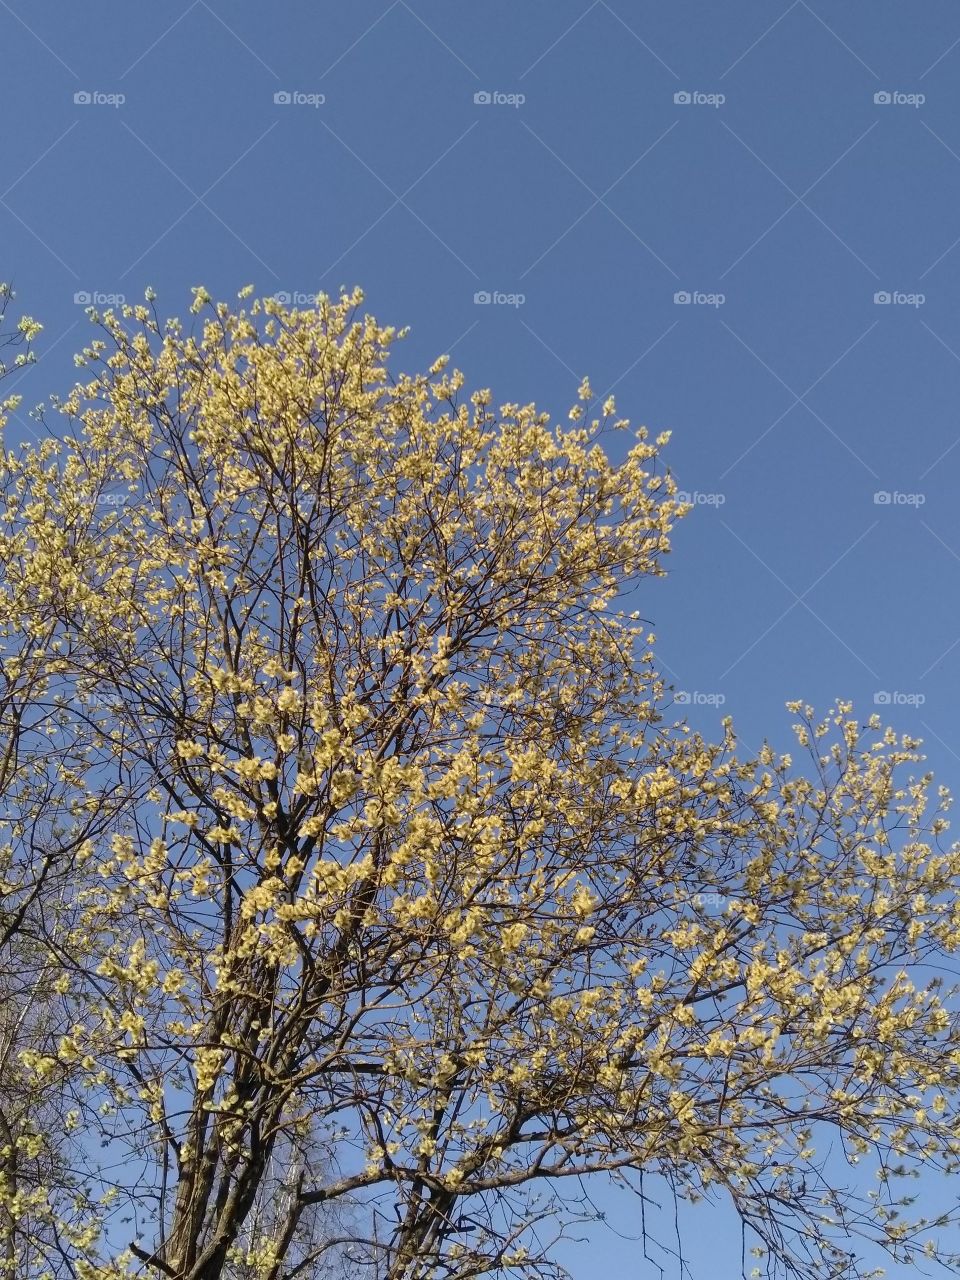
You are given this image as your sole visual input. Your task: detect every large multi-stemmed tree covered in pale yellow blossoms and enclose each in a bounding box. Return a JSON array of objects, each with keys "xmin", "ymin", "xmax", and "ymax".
[{"xmin": 3, "ymin": 282, "xmax": 960, "ymax": 1280}]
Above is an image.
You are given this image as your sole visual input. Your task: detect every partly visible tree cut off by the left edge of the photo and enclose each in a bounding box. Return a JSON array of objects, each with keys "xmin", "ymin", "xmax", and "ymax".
[{"xmin": 0, "ymin": 285, "xmax": 133, "ymax": 1276}]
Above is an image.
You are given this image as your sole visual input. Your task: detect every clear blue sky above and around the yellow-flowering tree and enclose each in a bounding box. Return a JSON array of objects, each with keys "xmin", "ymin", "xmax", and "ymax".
[{"xmin": 0, "ymin": 0, "xmax": 960, "ymax": 1280}]
